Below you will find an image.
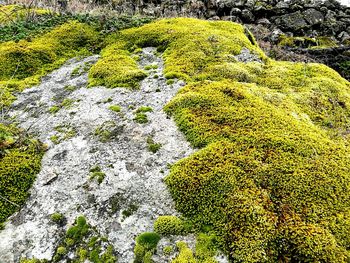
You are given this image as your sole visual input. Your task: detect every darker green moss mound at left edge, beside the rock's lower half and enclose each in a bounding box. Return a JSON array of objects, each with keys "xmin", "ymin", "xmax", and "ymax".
[{"xmin": 0, "ymin": 124, "xmax": 44, "ymax": 223}]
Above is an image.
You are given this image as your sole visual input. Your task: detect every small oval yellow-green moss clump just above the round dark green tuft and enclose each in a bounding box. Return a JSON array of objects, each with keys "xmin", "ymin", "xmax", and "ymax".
[{"xmin": 154, "ymin": 216, "xmax": 184, "ymax": 236}]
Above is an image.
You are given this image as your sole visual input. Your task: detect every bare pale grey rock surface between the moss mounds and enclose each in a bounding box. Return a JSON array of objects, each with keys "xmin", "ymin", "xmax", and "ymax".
[{"xmin": 0, "ymin": 48, "xmax": 197, "ymax": 263}]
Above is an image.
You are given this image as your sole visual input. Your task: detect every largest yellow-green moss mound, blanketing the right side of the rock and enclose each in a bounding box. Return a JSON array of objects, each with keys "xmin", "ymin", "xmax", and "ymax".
[{"xmin": 90, "ymin": 18, "xmax": 350, "ymax": 262}]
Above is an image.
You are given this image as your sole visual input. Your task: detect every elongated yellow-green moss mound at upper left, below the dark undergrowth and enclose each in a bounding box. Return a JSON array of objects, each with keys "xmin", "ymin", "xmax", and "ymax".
[{"xmin": 0, "ymin": 21, "xmax": 98, "ymax": 107}]
